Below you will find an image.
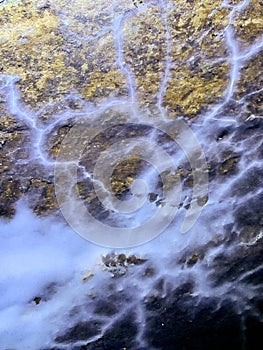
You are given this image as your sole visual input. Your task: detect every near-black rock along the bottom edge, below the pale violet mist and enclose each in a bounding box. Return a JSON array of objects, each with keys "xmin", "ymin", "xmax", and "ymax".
[{"xmin": 43, "ymin": 276, "xmax": 263, "ymax": 350}]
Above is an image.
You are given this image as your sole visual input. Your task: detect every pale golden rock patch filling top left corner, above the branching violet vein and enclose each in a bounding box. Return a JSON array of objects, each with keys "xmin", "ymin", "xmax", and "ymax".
[{"xmin": 0, "ymin": 0, "xmax": 129, "ymax": 109}]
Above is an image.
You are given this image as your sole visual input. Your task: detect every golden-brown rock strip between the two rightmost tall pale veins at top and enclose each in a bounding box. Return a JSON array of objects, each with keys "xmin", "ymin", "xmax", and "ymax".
[{"xmin": 164, "ymin": 1, "xmax": 229, "ymax": 118}]
